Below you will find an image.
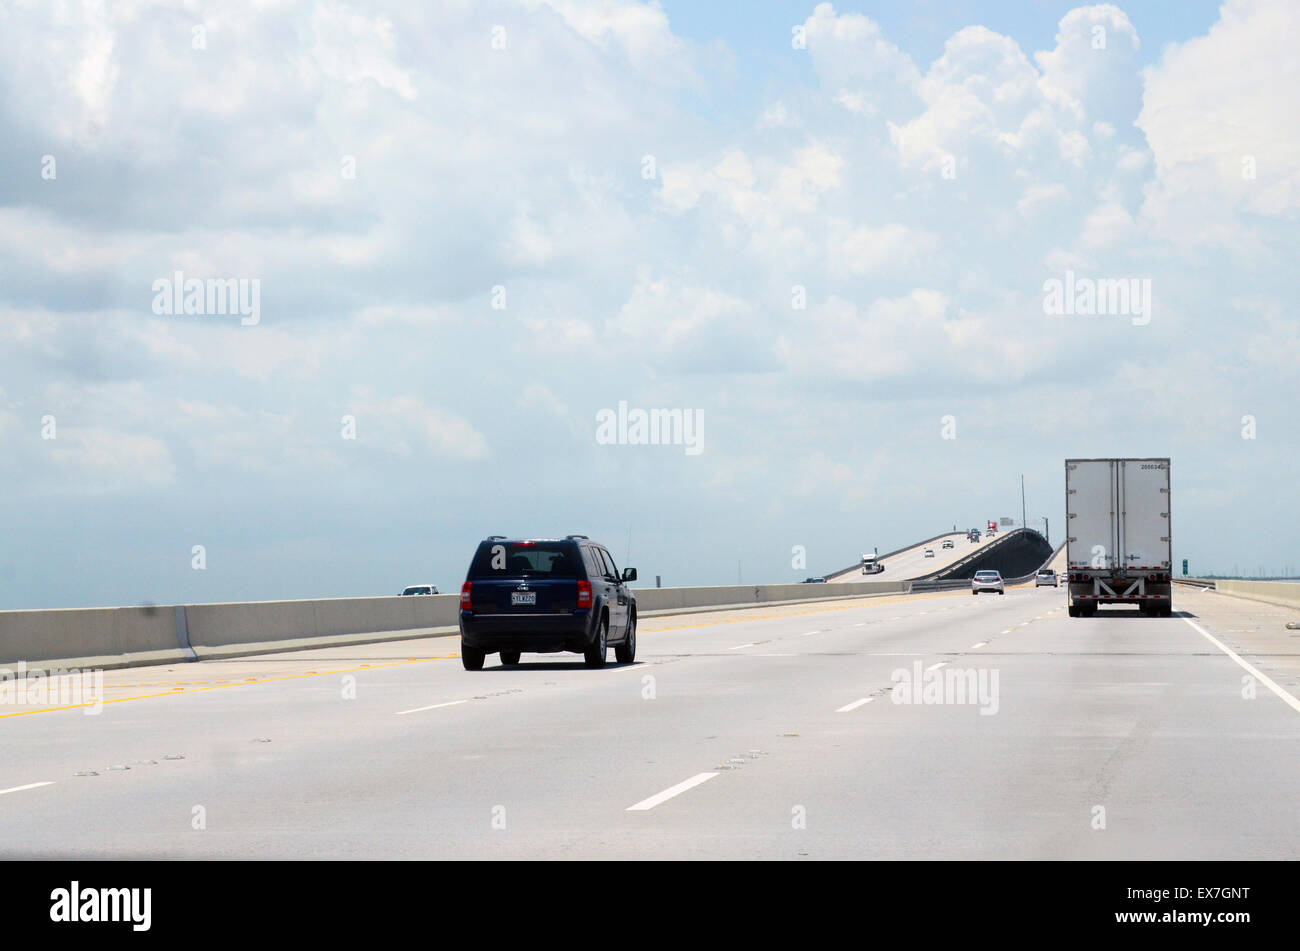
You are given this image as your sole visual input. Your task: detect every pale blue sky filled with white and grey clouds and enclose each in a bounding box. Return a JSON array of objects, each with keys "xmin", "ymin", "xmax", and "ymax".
[{"xmin": 0, "ymin": 0, "xmax": 1300, "ymax": 608}]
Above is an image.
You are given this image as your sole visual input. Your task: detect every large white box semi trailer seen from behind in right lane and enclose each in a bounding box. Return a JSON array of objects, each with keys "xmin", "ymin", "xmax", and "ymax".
[{"xmin": 1065, "ymin": 459, "xmax": 1174, "ymax": 617}]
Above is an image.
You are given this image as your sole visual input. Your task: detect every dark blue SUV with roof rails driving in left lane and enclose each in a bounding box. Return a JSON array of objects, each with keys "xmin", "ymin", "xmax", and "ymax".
[{"xmin": 460, "ymin": 535, "xmax": 637, "ymax": 670}]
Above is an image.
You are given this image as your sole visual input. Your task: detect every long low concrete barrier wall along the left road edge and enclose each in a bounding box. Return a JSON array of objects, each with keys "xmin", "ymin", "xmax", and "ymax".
[{"xmin": 0, "ymin": 581, "xmax": 909, "ymax": 668}]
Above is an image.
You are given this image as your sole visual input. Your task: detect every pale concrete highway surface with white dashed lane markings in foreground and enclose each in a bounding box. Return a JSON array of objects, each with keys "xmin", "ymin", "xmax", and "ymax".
[{"xmin": 0, "ymin": 587, "xmax": 1300, "ymax": 860}]
